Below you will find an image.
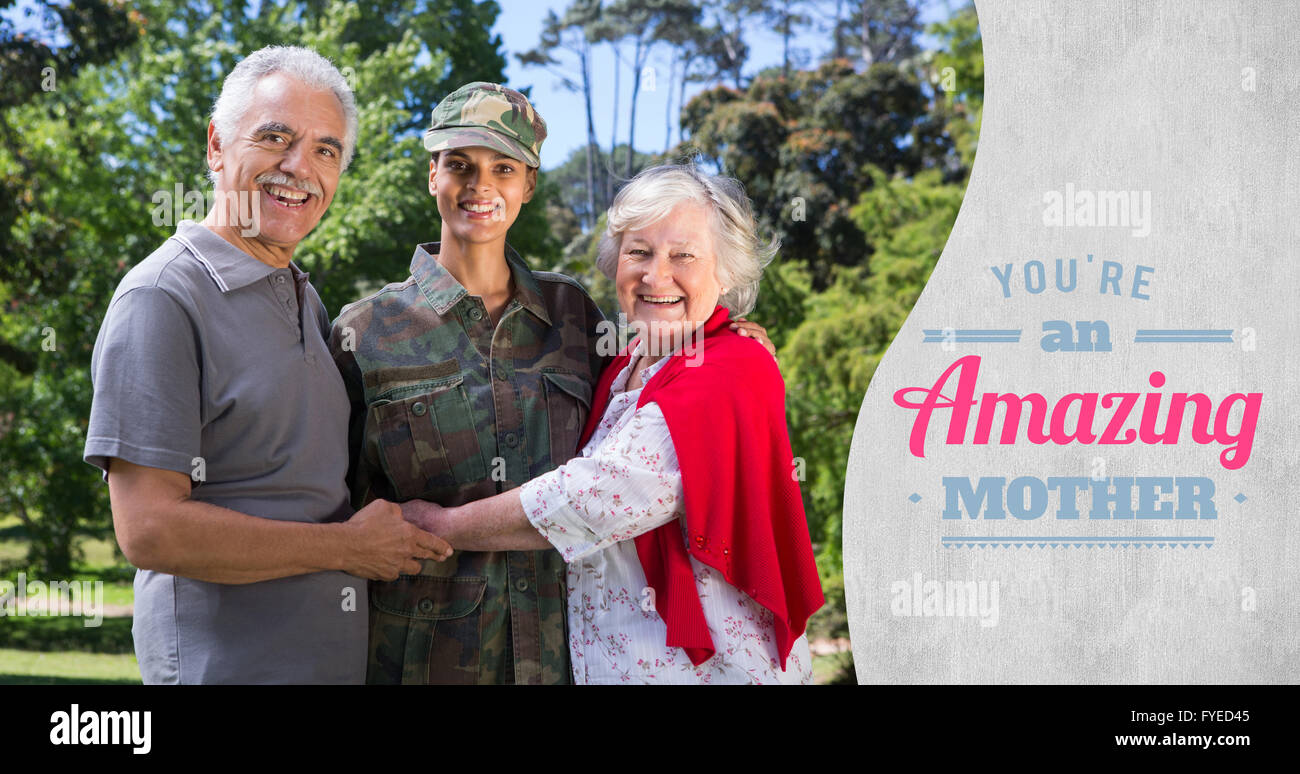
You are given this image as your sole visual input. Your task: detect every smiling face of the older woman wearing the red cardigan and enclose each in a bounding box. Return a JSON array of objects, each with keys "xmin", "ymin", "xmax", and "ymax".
[{"xmin": 614, "ymin": 202, "xmax": 722, "ymax": 353}]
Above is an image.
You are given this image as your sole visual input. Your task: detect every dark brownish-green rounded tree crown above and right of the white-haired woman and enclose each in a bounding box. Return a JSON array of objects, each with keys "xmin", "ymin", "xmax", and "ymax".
[{"xmin": 681, "ymin": 60, "xmax": 949, "ymax": 290}]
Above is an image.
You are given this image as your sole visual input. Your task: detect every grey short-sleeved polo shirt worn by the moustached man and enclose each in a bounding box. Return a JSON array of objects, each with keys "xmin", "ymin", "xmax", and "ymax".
[{"xmin": 85, "ymin": 221, "xmax": 368, "ymax": 683}]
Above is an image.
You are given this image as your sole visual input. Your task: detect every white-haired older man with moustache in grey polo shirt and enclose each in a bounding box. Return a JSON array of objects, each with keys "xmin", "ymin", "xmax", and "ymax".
[{"xmin": 85, "ymin": 47, "xmax": 451, "ymax": 683}]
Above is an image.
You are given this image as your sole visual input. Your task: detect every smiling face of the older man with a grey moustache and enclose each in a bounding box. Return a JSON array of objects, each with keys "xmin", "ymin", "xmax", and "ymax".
[{"xmin": 208, "ymin": 73, "xmax": 346, "ymax": 252}]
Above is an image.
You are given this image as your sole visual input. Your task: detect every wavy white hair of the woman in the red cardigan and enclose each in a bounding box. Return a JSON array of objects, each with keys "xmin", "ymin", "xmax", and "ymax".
[{"xmin": 595, "ymin": 164, "xmax": 780, "ymax": 316}]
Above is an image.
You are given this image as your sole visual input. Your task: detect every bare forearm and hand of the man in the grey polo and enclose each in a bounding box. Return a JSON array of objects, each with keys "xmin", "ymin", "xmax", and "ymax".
[{"xmin": 108, "ymin": 458, "xmax": 451, "ymax": 584}]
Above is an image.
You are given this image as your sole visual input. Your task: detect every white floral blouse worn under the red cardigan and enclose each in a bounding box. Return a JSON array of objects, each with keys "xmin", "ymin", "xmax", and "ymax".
[{"xmin": 520, "ymin": 358, "xmax": 813, "ymax": 684}]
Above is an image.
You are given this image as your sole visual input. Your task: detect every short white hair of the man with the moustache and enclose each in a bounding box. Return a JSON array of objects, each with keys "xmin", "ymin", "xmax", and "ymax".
[{"xmin": 208, "ymin": 46, "xmax": 356, "ymax": 182}]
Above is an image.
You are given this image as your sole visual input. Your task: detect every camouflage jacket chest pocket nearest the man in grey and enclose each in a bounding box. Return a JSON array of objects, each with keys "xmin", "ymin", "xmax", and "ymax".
[{"xmin": 371, "ymin": 375, "xmax": 486, "ymax": 500}]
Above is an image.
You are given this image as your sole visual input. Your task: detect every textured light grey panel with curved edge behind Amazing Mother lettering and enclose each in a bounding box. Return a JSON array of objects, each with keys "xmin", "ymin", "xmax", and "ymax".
[{"xmin": 844, "ymin": 0, "xmax": 1300, "ymax": 683}]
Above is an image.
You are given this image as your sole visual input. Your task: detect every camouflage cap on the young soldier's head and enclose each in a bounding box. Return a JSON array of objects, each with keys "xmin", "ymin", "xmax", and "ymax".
[{"xmin": 424, "ymin": 81, "xmax": 546, "ymax": 167}]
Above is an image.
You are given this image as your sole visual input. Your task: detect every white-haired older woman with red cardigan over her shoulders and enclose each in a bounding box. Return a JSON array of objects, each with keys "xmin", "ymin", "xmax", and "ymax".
[{"xmin": 403, "ymin": 167, "xmax": 823, "ymax": 683}]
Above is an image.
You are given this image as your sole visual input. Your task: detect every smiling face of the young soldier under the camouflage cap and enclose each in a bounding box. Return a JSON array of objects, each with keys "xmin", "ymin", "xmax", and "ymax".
[{"xmin": 429, "ymin": 146, "xmax": 537, "ymax": 243}]
